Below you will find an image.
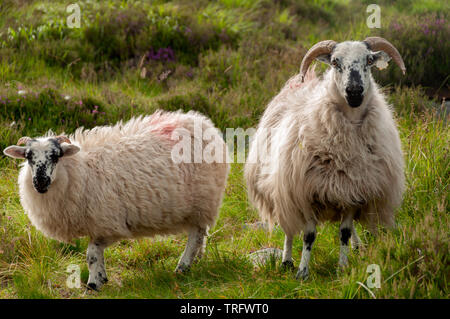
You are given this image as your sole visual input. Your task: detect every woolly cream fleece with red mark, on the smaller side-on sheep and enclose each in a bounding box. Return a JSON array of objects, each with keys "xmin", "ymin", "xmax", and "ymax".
[{"xmin": 19, "ymin": 111, "xmax": 228, "ymax": 242}]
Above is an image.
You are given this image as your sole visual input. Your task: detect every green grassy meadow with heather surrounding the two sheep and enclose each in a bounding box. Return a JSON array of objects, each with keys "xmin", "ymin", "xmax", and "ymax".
[{"xmin": 0, "ymin": 0, "xmax": 450, "ymax": 298}]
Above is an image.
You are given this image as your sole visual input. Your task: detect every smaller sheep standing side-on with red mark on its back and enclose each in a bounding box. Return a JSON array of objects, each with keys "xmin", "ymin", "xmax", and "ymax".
[{"xmin": 4, "ymin": 111, "xmax": 228, "ymax": 289}]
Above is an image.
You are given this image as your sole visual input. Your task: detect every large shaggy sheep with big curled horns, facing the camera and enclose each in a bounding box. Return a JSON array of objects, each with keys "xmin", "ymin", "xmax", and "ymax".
[{"xmin": 245, "ymin": 37, "xmax": 406, "ymax": 279}]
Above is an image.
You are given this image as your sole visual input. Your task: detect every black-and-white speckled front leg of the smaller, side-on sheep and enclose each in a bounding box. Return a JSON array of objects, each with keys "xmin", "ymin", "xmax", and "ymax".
[{"xmin": 86, "ymin": 240, "xmax": 108, "ymax": 290}]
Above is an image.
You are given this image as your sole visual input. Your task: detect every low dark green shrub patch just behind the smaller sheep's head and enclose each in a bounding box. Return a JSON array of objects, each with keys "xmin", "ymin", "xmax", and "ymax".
[{"xmin": 0, "ymin": 88, "xmax": 121, "ymax": 149}]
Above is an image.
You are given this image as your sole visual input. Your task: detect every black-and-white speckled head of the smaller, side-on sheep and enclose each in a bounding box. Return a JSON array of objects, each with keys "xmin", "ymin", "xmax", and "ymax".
[{"xmin": 3, "ymin": 138, "xmax": 80, "ymax": 194}]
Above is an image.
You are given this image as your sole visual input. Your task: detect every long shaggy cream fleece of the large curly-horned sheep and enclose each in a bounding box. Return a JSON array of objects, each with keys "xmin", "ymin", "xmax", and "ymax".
[{"xmin": 245, "ymin": 69, "xmax": 404, "ymax": 235}]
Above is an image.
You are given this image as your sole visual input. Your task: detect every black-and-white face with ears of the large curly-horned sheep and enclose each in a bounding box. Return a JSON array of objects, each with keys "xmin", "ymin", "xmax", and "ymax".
[{"xmin": 318, "ymin": 41, "xmax": 390, "ymax": 108}]
